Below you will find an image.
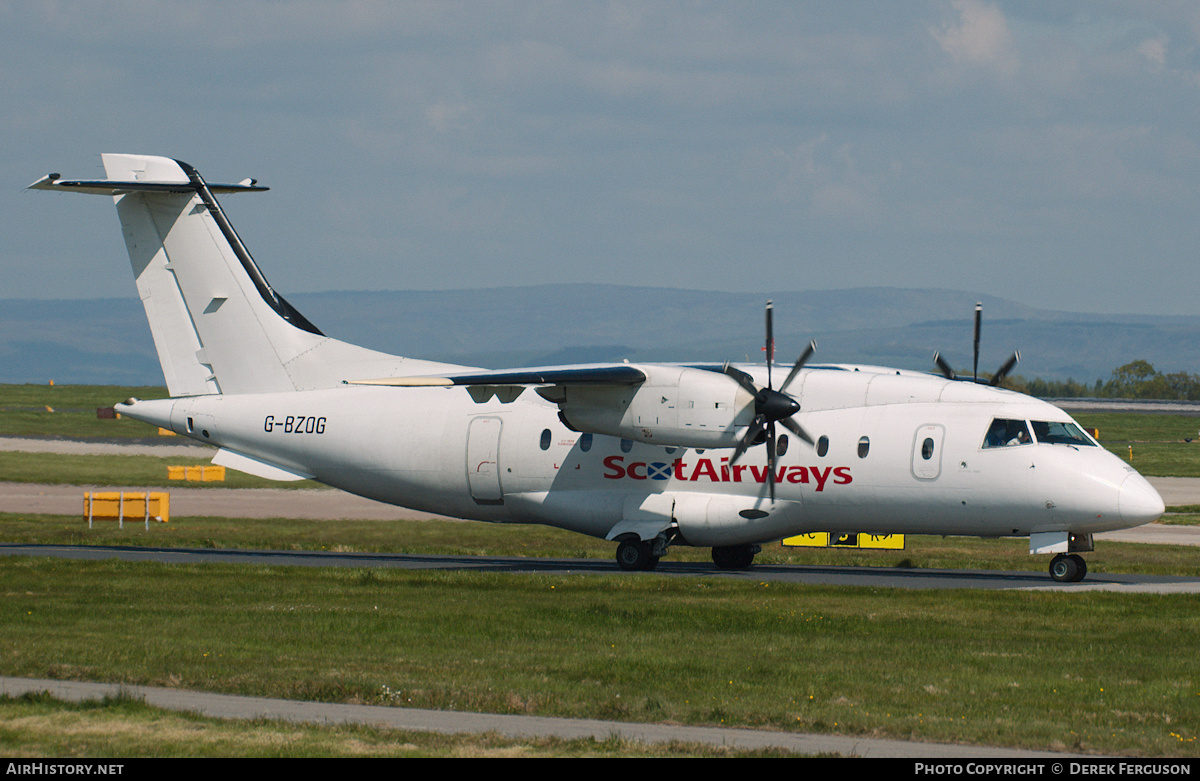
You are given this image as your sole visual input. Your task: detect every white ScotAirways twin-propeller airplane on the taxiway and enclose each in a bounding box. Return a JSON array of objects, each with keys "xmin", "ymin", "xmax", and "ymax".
[{"xmin": 30, "ymin": 154, "xmax": 1164, "ymax": 582}]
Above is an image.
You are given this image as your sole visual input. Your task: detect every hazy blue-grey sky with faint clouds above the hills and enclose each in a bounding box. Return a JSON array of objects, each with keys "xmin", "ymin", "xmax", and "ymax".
[{"xmin": 0, "ymin": 0, "xmax": 1200, "ymax": 314}]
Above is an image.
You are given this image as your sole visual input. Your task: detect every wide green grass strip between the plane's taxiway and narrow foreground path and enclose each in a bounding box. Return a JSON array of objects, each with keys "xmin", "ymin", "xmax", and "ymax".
[{"xmin": 0, "ymin": 558, "xmax": 1200, "ymax": 756}]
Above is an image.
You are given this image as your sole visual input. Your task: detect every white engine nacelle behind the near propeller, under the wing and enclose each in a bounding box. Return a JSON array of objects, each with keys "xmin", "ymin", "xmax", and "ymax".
[{"xmin": 542, "ymin": 364, "xmax": 754, "ymax": 447}]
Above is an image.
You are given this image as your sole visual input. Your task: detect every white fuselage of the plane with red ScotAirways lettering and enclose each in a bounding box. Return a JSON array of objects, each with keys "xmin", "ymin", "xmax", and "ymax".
[{"xmin": 122, "ymin": 367, "xmax": 1163, "ymax": 546}]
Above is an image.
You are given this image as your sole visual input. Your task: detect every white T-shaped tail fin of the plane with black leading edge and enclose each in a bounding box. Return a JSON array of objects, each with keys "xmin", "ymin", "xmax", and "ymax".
[{"xmin": 30, "ymin": 155, "xmax": 446, "ymax": 396}]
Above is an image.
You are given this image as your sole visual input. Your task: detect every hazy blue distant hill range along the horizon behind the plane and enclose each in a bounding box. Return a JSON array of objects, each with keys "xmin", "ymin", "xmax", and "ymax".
[{"xmin": 0, "ymin": 284, "xmax": 1200, "ymax": 384}]
